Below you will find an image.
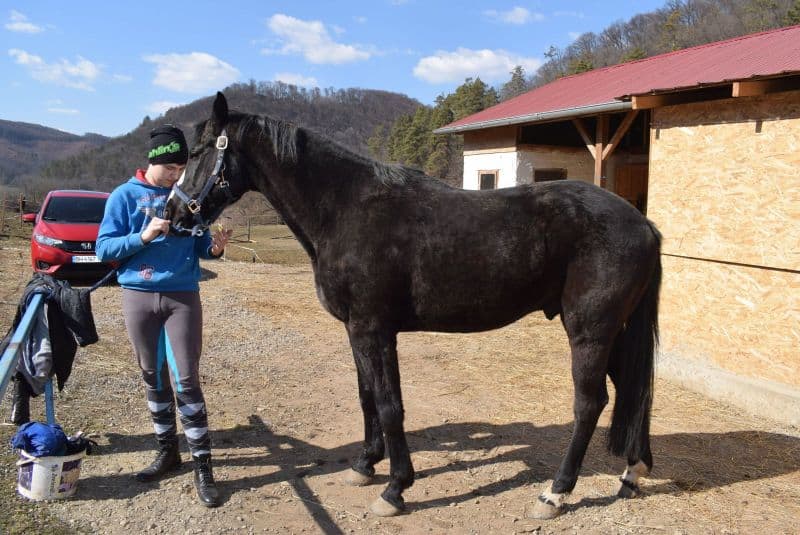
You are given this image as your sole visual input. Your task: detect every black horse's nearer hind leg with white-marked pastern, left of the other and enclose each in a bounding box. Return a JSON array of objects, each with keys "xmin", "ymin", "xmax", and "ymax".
[{"xmin": 531, "ymin": 336, "xmax": 609, "ymax": 519}]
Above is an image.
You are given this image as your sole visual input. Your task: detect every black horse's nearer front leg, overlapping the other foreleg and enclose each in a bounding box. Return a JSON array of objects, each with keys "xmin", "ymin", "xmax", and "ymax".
[{"xmin": 347, "ymin": 322, "xmax": 414, "ymax": 516}]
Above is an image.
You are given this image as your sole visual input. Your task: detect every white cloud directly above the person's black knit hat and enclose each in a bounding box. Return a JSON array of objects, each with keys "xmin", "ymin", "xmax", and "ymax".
[{"xmin": 143, "ymin": 52, "xmax": 239, "ymax": 94}]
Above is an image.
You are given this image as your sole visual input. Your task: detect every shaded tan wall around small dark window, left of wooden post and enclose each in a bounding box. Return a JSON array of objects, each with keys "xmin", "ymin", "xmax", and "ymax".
[{"xmin": 517, "ymin": 145, "xmax": 594, "ymax": 184}]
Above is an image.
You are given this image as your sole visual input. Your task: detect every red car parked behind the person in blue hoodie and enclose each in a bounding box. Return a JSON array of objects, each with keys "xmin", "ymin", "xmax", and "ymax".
[{"xmin": 22, "ymin": 190, "xmax": 115, "ymax": 279}]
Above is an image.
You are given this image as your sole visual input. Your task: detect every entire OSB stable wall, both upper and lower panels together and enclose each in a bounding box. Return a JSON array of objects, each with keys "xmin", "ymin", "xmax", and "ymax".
[{"xmin": 648, "ymin": 91, "xmax": 800, "ymax": 388}]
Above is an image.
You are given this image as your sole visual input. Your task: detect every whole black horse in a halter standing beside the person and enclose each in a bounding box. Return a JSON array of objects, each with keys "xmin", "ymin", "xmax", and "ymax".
[{"xmin": 167, "ymin": 93, "xmax": 661, "ymax": 518}]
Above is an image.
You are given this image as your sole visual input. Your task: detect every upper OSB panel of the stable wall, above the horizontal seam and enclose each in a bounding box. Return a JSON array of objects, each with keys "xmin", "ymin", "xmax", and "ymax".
[{"xmin": 648, "ymin": 91, "xmax": 800, "ymax": 270}]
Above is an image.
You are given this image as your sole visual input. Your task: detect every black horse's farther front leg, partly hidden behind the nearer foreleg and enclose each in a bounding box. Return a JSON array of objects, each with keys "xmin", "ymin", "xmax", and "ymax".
[{"xmin": 345, "ymin": 358, "xmax": 384, "ymax": 487}]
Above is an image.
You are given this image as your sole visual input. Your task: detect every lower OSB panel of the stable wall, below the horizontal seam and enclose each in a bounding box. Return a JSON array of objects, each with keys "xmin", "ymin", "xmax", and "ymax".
[{"xmin": 659, "ymin": 256, "xmax": 800, "ymax": 388}]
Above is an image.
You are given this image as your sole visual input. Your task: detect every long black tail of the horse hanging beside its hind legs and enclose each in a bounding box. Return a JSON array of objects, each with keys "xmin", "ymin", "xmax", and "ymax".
[{"xmin": 607, "ymin": 229, "xmax": 661, "ymax": 459}]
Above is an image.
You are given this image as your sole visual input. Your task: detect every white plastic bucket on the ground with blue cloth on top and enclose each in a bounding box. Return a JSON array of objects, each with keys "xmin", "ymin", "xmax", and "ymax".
[{"xmin": 17, "ymin": 450, "xmax": 86, "ymax": 500}]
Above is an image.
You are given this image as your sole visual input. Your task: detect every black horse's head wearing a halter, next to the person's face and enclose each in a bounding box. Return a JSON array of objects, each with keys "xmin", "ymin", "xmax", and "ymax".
[{"xmin": 166, "ymin": 93, "xmax": 248, "ymax": 235}]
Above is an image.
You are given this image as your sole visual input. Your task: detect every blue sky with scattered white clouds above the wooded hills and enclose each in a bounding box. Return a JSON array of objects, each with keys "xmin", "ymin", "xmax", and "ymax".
[{"xmin": 0, "ymin": 0, "xmax": 664, "ymax": 136}]
